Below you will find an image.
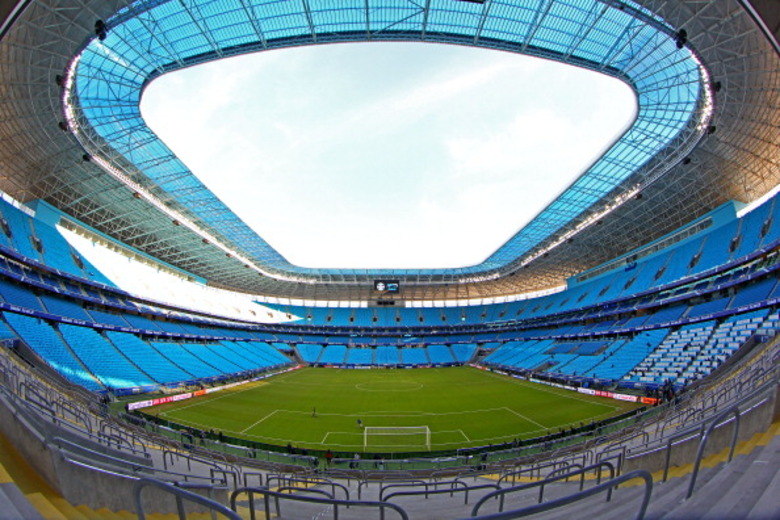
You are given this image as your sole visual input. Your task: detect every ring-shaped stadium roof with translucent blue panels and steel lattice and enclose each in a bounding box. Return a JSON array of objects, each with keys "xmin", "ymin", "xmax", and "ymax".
[{"xmin": 0, "ymin": 0, "xmax": 780, "ymax": 300}]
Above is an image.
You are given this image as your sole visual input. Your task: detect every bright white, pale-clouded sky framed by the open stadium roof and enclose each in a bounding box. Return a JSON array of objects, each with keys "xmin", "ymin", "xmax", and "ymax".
[{"xmin": 141, "ymin": 43, "xmax": 636, "ymax": 269}]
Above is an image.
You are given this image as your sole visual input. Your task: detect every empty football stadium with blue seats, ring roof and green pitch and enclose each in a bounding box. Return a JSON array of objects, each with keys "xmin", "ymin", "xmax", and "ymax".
[{"xmin": 0, "ymin": 0, "xmax": 780, "ymax": 520}]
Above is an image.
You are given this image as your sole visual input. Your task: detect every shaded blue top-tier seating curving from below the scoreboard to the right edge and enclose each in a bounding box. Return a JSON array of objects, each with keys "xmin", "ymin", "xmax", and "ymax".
[{"xmin": 274, "ymin": 195, "xmax": 780, "ymax": 327}]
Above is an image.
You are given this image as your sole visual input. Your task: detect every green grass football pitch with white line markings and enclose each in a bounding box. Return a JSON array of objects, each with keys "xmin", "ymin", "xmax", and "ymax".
[{"xmin": 145, "ymin": 367, "xmax": 636, "ymax": 452}]
